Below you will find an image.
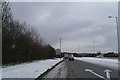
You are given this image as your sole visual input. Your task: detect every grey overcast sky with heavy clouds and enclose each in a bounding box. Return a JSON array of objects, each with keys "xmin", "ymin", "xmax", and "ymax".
[{"xmin": 11, "ymin": 2, "xmax": 118, "ymax": 52}]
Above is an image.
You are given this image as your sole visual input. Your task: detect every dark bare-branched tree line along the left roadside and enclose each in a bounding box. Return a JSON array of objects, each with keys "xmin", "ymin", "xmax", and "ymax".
[{"xmin": 2, "ymin": 2, "xmax": 55, "ymax": 64}]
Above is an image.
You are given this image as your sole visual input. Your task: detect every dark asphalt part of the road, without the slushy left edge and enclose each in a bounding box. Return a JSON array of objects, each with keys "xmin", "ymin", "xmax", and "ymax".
[{"xmin": 65, "ymin": 60, "xmax": 118, "ymax": 80}]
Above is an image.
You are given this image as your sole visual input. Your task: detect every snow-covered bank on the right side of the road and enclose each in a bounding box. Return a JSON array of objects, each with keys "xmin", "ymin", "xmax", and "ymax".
[{"xmin": 75, "ymin": 57, "xmax": 118, "ymax": 70}]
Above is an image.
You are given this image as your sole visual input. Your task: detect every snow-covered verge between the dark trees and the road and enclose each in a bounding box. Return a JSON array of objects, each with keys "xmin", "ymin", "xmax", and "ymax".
[{"xmin": 2, "ymin": 59, "xmax": 62, "ymax": 78}]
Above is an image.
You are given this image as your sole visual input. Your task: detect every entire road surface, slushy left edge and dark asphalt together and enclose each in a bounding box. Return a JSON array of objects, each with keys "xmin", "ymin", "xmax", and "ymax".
[{"xmin": 41, "ymin": 60, "xmax": 118, "ymax": 80}]
